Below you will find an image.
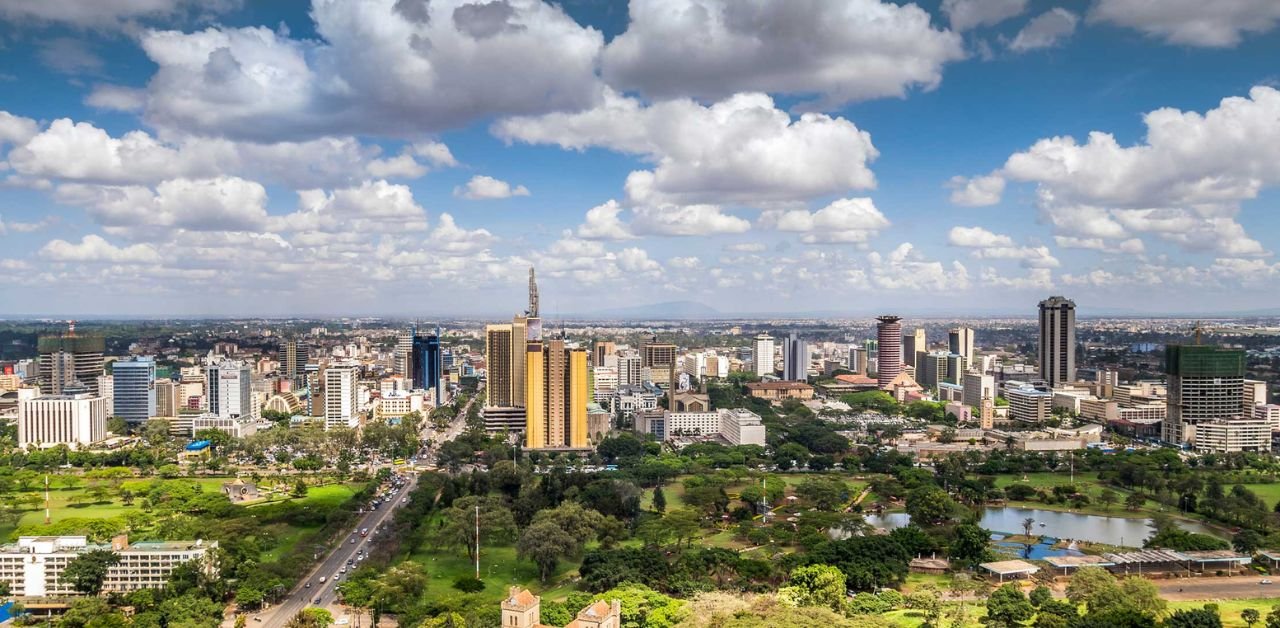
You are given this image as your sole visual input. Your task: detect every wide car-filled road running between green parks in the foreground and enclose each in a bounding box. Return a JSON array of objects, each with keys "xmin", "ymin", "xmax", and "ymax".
[{"xmin": 256, "ymin": 473, "xmax": 417, "ymax": 628}]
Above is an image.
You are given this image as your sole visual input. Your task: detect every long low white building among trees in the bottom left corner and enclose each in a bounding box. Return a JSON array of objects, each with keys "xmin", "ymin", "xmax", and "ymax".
[{"xmin": 0, "ymin": 536, "xmax": 218, "ymax": 597}]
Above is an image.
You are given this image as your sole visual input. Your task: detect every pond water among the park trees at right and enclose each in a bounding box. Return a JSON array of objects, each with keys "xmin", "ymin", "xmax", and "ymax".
[{"xmin": 867, "ymin": 506, "xmax": 1216, "ymax": 547}]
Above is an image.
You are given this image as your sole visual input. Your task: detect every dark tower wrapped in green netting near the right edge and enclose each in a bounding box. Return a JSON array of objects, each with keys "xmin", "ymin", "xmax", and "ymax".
[{"xmin": 1161, "ymin": 344, "xmax": 1252, "ymax": 444}]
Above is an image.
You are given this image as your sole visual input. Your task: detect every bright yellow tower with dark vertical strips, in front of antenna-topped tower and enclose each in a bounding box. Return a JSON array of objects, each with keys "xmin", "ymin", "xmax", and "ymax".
[{"xmin": 525, "ymin": 339, "xmax": 593, "ymax": 449}]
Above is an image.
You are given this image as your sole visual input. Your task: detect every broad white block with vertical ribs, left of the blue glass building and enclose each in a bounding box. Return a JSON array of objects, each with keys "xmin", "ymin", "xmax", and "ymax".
[{"xmin": 18, "ymin": 393, "xmax": 110, "ymax": 449}]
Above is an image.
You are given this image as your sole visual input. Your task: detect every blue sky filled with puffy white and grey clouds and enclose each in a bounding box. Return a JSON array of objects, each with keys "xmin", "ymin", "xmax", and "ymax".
[{"xmin": 0, "ymin": 0, "xmax": 1280, "ymax": 317}]
